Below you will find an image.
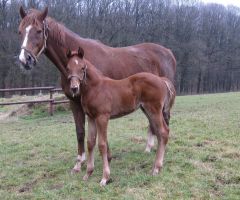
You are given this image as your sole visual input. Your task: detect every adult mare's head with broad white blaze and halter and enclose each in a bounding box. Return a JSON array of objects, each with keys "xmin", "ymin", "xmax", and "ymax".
[{"xmin": 18, "ymin": 7, "xmax": 48, "ymax": 70}]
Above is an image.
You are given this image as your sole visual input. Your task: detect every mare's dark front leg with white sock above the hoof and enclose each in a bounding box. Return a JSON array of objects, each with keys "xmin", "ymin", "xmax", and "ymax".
[{"xmin": 70, "ymin": 100, "xmax": 86, "ymax": 173}]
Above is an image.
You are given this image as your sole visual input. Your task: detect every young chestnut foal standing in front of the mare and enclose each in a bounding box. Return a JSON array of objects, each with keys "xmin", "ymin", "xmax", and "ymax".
[{"xmin": 67, "ymin": 48, "xmax": 175, "ymax": 186}]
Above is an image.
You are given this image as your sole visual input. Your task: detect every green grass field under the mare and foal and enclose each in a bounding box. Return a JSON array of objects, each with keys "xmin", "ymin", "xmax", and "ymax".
[{"xmin": 0, "ymin": 93, "xmax": 240, "ymax": 200}]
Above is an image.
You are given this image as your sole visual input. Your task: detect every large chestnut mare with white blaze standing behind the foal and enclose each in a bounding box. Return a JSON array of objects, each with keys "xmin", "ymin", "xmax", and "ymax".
[{"xmin": 19, "ymin": 7, "xmax": 176, "ymax": 172}]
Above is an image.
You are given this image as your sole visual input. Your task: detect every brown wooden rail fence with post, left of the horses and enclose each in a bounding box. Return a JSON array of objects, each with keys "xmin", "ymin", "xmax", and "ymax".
[{"xmin": 0, "ymin": 86, "xmax": 69, "ymax": 116}]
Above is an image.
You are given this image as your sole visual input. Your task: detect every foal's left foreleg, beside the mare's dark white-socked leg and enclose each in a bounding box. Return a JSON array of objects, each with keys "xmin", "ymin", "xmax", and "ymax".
[{"xmin": 83, "ymin": 117, "xmax": 97, "ymax": 181}]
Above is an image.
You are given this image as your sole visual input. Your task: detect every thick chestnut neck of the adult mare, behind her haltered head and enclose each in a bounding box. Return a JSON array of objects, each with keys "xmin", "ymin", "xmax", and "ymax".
[{"xmin": 45, "ymin": 18, "xmax": 85, "ymax": 78}]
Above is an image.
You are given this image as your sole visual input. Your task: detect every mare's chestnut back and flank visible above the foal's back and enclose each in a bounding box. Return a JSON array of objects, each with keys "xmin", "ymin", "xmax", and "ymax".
[{"xmin": 84, "ymin": 43, "xmax": 176, "ymax": 82}]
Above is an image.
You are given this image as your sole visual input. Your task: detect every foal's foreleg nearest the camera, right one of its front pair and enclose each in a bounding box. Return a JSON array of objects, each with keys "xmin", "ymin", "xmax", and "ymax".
[{"xmin": 96, "ymin": 115, "xmax": 110, "ymax": 186}]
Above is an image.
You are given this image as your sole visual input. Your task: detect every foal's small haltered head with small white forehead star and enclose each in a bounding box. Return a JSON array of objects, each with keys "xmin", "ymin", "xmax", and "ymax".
[{"xmin": 67, "ymin": 47, "xmax": 87, "ymax": 97}]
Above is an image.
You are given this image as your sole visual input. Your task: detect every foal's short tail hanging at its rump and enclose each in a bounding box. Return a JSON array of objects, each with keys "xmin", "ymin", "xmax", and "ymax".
[{"xmin": 162, "ymin": 78, "xmax": 176, "ymax": 126}]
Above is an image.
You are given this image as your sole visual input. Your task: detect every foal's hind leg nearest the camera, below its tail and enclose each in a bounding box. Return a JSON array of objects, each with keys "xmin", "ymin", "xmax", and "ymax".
[{"xmin": 152, "ymin": 112, "xmax": 169, "ymax": 176}]
